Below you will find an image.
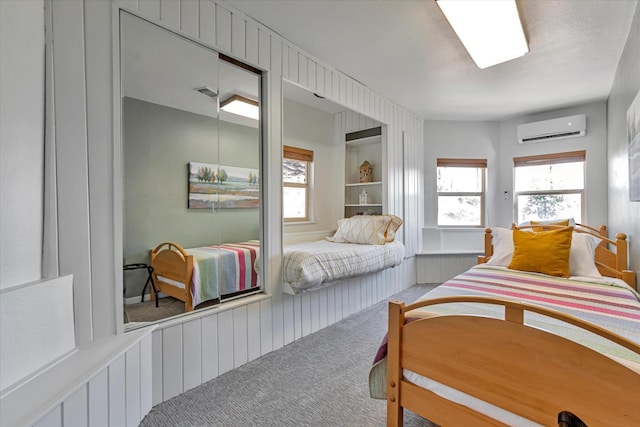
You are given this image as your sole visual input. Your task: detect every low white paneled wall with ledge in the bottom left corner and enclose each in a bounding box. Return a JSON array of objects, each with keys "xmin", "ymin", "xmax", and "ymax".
[{"xmin": 0, "ymin": 329, "xmax": 152, "ymax": 427}]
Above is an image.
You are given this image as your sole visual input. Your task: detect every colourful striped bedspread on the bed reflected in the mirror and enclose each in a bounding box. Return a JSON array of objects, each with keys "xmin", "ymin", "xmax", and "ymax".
[{"xmin": 186, "ymin": 241, "xmax": 260, "ymax": 306}]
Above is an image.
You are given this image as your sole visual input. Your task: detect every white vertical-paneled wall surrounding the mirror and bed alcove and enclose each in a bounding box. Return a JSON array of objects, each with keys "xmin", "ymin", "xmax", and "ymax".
[{"xmin": 47, "ymin": 0, "xmax": 424, "ymax": 425}]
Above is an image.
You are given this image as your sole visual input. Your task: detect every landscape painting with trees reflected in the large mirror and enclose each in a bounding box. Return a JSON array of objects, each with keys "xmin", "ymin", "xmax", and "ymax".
[{"xmin": 188, "ymin": 162, "xmax": 260, "ymax": 209}]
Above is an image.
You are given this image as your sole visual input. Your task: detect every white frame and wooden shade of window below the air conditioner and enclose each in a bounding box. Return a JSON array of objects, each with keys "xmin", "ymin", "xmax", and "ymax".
[{"xmin": 513, "ymin": 150, "xmax": 587, "ymax": 223}]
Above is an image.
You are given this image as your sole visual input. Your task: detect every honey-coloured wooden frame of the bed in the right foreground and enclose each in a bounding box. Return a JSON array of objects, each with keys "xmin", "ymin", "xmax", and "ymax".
[{"xmin": 387, "ymin": 227, "xmax": 640, "ymax": 427}]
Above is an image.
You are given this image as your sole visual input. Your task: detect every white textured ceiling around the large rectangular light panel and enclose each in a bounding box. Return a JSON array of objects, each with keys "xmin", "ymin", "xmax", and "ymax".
[{"xmin": 226, "ymin": 0, "xmax": 638, "ymax": 120}]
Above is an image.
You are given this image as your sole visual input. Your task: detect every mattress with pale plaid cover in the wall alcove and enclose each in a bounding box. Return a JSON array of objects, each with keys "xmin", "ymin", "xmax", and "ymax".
[{"xmin": 282, "ymin": 240, "xmax": 404, "ymax": 294}]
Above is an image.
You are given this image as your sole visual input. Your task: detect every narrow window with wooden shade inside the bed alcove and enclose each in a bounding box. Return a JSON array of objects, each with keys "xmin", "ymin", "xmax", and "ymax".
[{"xmin": 282, "ymin": 145, "xmax": 313, "ymax": 222}]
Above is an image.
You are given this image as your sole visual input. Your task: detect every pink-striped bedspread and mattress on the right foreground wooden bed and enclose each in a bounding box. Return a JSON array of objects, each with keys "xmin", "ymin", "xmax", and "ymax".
[{"xmin": 369, "ymin": 264, "xmax": 640, "ymax": 426}]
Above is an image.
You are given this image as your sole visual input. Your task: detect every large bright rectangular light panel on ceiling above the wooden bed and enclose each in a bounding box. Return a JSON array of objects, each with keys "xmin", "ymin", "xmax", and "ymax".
[{"xmin": 436, "ymin": 0, "xmax": 529, "ymax": 68}]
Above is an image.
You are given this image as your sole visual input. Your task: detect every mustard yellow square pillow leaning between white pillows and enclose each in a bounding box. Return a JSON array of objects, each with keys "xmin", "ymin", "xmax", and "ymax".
[{"xmin": 508, "ymin": 227, "xmax": 573, "ymax": 277}]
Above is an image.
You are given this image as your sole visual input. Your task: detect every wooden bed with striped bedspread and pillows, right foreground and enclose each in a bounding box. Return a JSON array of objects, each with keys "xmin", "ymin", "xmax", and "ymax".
[{"xmin": 369, "ymin": 225, "xmax": 640, "ymax": 426}]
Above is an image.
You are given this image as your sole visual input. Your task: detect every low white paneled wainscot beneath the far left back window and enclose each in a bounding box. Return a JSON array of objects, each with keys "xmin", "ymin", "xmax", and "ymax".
[{"xmin": 416, "ymin": 253, "xmax": 482, "ymax": 283}]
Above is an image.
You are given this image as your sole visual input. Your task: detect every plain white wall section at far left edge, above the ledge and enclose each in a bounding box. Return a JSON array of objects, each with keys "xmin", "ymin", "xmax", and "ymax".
[{"xmin": 0, "ymin": 0, "xmax": 44, "ymax": 289}]
